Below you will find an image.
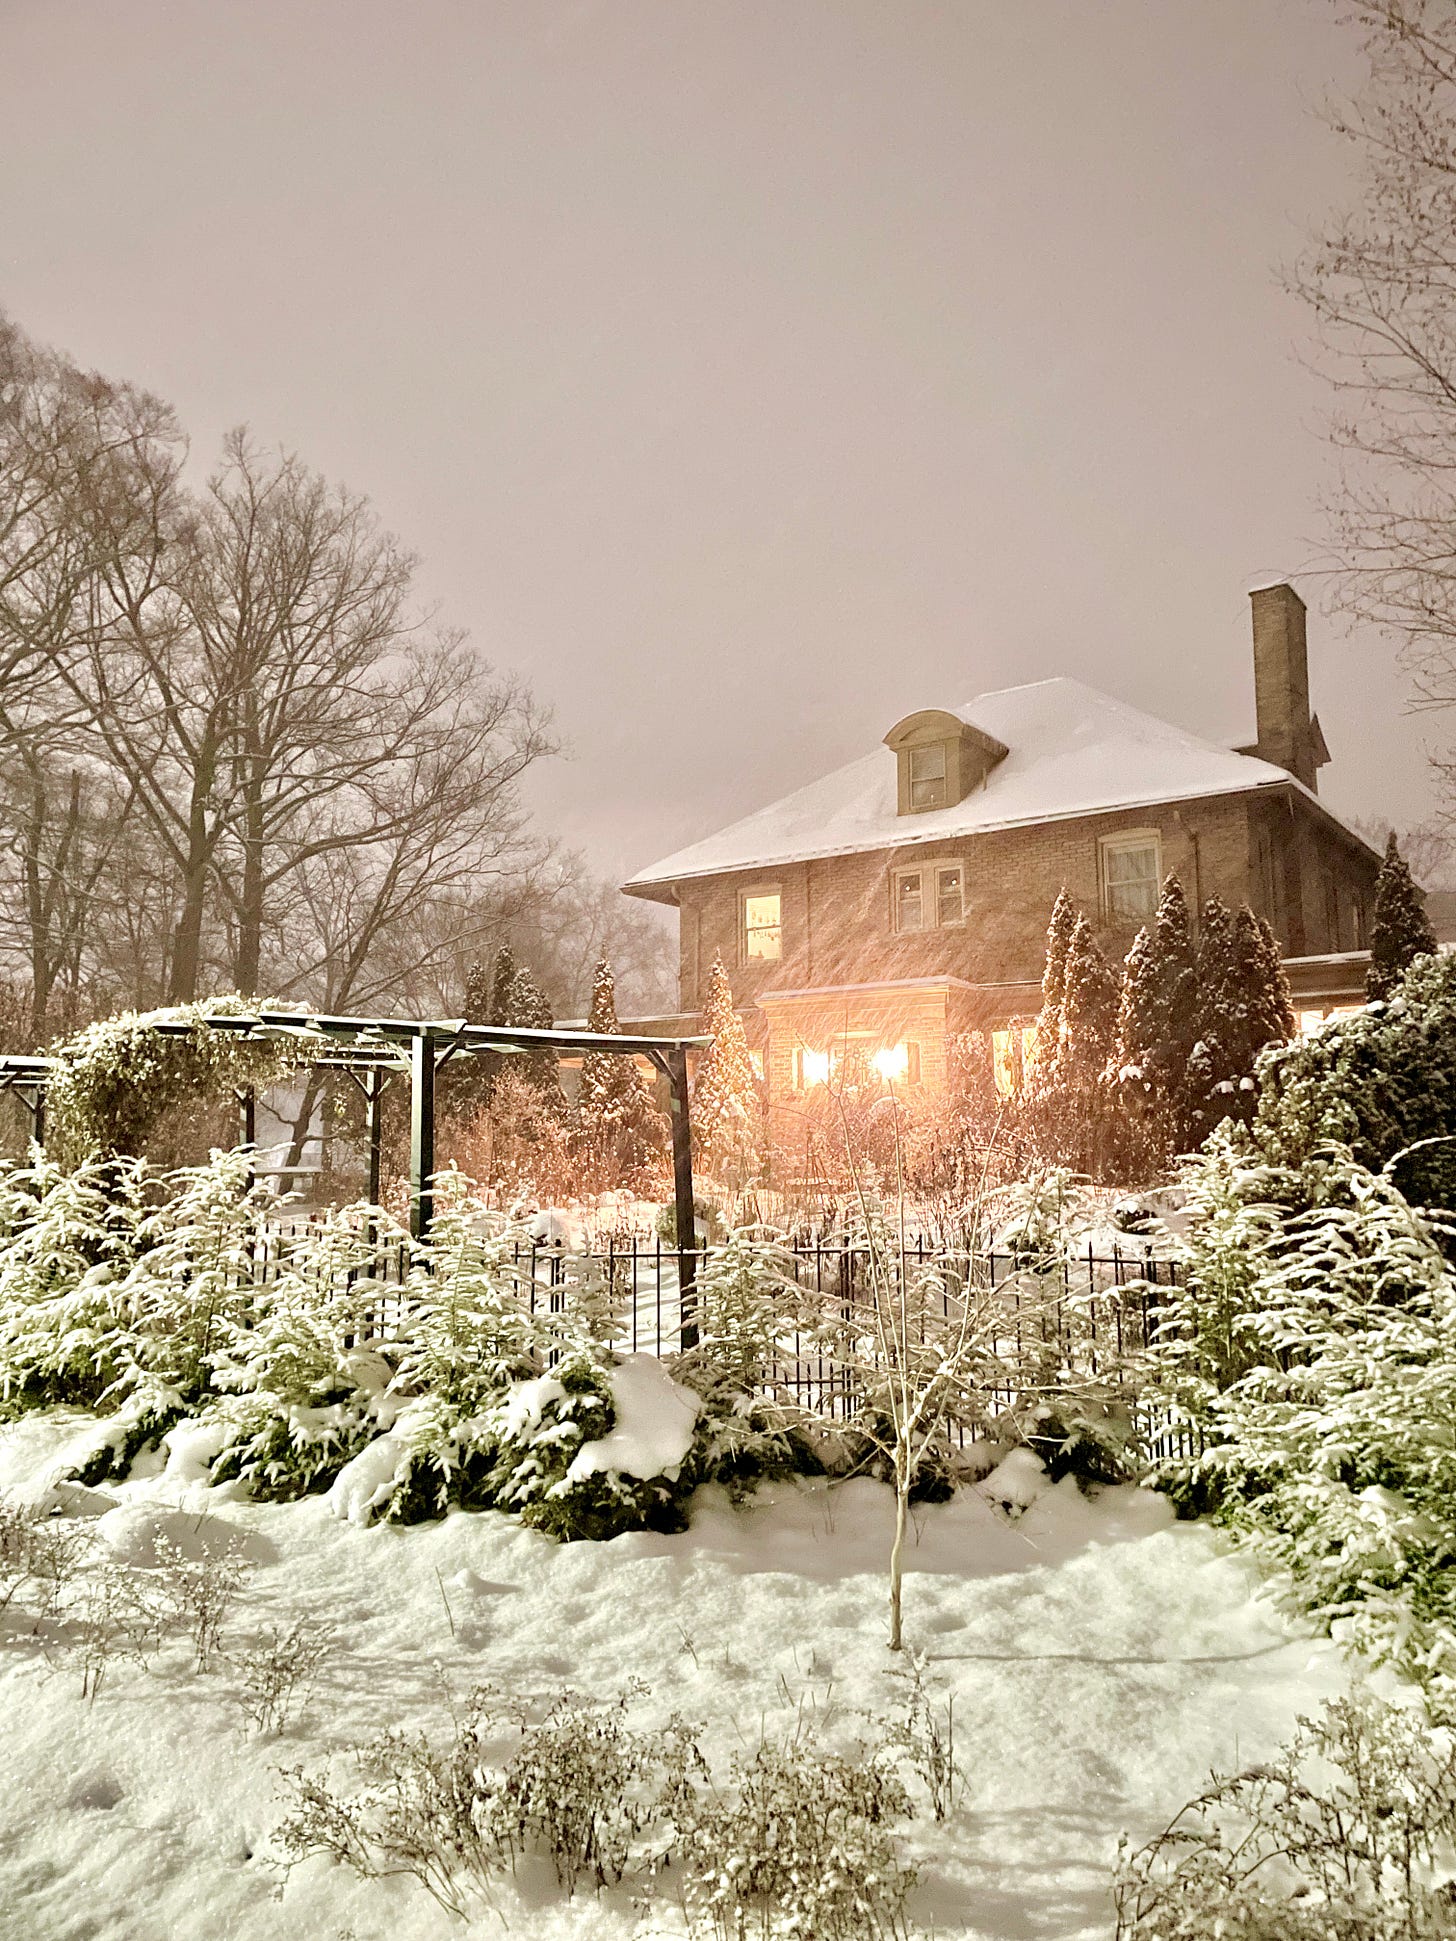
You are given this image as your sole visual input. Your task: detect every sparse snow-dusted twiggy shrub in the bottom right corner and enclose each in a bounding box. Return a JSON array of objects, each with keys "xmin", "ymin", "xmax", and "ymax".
[{"xmin": 1116, "ymin": 1698, "xmax": 1456, "ymax": 1941}]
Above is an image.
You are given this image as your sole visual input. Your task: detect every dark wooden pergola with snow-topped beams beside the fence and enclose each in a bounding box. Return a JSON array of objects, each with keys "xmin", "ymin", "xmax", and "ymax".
[{"xmin": 0, "ymin": 1009, "xmax": 712, "ymax": 1347}]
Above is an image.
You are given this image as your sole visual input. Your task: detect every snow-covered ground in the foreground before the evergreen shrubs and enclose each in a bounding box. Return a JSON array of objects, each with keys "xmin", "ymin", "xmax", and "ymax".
[{"xmin": 0, "ymin": 1413, "xmax": 1351, "ymax": 1941}]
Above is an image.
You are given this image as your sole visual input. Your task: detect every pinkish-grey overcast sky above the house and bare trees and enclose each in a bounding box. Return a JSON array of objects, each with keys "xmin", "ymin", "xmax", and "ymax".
[{"xmin": 0, "ymin": 0, "xmax": 1456, "ymax": 875}]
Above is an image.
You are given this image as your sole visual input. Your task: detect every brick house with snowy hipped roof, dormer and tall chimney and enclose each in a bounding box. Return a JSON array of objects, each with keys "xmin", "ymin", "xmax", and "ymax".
[{"xmin": 623, "ymin": 582, "xmax": 1380, "ymax": 1099}]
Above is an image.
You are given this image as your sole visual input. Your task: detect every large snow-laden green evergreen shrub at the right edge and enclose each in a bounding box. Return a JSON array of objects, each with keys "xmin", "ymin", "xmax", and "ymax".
[{"xmin": 1159, "ymin": 1141, "xmax": 1456, "ymax": 1712}]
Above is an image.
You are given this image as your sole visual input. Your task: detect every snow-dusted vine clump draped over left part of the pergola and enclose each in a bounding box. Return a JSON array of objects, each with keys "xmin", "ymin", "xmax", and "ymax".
[{"xmin": 47, "ymin": 996, "xmax": 307, "ymax": 1165}]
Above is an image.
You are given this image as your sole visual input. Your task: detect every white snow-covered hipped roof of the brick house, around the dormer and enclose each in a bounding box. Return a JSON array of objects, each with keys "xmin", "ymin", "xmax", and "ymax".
[{"xmin": 623, "ymin": 679, "xmax": 1353, "ymax": 895}]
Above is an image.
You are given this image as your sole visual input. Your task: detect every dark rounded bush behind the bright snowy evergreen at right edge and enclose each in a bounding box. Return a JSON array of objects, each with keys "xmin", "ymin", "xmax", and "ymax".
[{"xmin": 1254, "ymin": 955, "xmax": 1456, "ymax": 1211}]
